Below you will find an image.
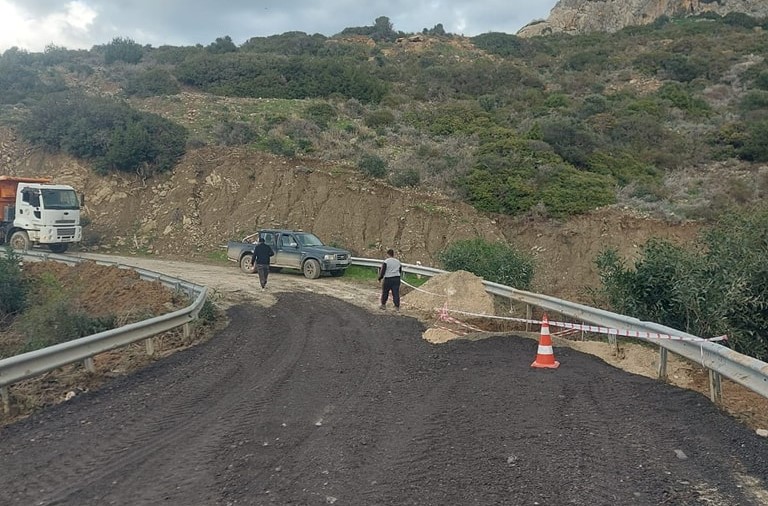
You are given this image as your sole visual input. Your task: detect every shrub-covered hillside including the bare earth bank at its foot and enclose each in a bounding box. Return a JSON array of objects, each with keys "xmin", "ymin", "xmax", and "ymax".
[{"xmin": 0, "ymin": 14, "xmax": 768, "ymax": 300}]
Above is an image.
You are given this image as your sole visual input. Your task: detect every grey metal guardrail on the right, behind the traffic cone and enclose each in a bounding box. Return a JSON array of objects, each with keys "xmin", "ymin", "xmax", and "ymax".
[{"xmin": 352, "ymin": 257, "xmax": 768, "ymax": 404}]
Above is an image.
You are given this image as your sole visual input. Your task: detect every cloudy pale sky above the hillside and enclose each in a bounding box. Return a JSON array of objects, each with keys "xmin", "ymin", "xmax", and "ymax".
[{"xmin": 0, "ymin": 0, "xmax": 557, "ymax": 53}]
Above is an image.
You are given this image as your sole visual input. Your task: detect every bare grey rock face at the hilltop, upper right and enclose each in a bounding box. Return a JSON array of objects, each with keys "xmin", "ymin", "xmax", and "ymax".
[{"xmin": 517, "ymin": 0, "xmax": 768, "ymax": 37}]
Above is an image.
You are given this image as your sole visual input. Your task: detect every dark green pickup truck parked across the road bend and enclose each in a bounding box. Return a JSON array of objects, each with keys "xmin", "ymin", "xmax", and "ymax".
[{"xmin": 227, "ymin": 229, "xmax": 352, "ymax": 279}]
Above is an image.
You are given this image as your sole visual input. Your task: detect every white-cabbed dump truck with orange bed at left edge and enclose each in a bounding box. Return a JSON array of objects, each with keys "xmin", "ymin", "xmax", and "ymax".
[{"xmin": 0, "ymin": 176, "xmax": 83, "ymax": 253}]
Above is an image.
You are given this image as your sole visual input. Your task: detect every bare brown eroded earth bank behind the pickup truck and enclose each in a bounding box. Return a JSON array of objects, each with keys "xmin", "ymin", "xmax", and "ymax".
[{"xmin": 0, "ymin": 125, "xmax": 699, "ymax": 302}]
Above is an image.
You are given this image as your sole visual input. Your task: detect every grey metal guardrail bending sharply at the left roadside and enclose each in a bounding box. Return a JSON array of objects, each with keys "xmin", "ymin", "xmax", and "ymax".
[{"xmin": 0, "ymin": 251, "xmax": 208, "ymax": 413}]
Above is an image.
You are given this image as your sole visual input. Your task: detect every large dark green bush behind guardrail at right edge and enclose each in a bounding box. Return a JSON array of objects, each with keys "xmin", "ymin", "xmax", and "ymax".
[{"xmin": 595, "ymin": 208, "xmax": 768, "ymax": 360}]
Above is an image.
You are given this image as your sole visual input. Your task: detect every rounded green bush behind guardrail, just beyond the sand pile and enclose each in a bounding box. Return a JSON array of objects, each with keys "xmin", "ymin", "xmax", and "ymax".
[{"xmin": 438, "ymin": 238, "xmax": 535, "ymax": 290}]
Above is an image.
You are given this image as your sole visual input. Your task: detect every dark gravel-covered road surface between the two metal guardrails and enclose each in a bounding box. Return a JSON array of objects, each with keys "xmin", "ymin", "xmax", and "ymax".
[{"xmin": 0, "ymin": 255, "xmax": 768, "ymax": 505}]
